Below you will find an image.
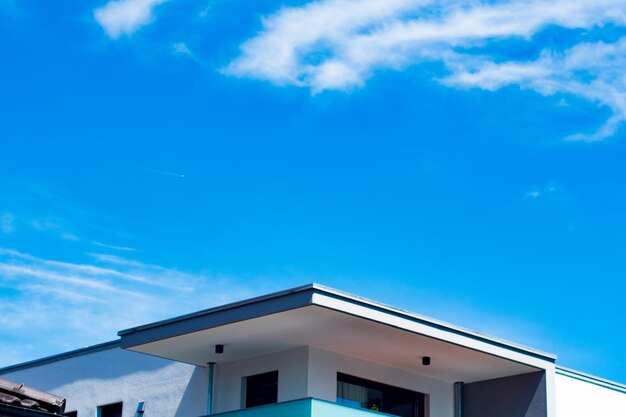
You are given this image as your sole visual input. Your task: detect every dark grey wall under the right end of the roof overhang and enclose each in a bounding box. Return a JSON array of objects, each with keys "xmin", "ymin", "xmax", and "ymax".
[{"xmin": 463, "ymin": 371, "xmax": 547, "ymax": 417}]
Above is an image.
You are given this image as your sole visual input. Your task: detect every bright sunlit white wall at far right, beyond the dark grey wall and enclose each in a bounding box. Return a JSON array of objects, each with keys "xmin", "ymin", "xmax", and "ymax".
[{"xmin": 556, "ymin": 373, "xmax": 626, "ymax": 417}]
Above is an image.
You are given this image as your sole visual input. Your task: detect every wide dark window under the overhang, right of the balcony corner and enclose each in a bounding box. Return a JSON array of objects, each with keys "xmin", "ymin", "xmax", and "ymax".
[{"xmin": 337, "ymin": 373, "xmax": 425, "ymax": 417}]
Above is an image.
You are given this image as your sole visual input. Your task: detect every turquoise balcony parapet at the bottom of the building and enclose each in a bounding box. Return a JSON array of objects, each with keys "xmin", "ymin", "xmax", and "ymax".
[{"xmin": 211, "ymin": 398, "xmax": 391, "ymax": 417}]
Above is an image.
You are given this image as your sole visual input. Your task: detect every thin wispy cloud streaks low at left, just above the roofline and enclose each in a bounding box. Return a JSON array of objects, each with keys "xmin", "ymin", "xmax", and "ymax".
[{"xmin": 0, "ymin": 248, "xmax": 249, "ymax": 366}]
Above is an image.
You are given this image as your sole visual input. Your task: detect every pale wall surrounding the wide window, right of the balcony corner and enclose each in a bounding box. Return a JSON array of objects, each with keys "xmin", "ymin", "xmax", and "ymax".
[{"xmin": 308, "ymin": 348, "xmax": 454, "ymax": 417}]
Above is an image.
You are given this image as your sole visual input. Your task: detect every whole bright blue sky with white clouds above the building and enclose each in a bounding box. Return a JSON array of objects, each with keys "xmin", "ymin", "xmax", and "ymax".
[{"xmin": 0, "ymin": 0, "xmax": 626, "ymax": 382}]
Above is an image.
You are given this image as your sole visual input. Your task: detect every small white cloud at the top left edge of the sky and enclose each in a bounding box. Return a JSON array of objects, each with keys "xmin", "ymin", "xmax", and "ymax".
[{"xmin": 94, "ymin": 0, "xmax": 168, "ymax": 39}]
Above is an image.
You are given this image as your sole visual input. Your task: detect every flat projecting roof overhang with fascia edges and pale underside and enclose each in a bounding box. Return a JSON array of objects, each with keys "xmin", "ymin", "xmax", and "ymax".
[{"xmin": 119, "ymin": 284, "xmax": 556, "ymax": 382}]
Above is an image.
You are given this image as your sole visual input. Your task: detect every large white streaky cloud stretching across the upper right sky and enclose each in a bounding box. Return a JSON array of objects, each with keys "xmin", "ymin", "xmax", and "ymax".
[{"xmin": 228, "ymin": 0, "xmax": 626, "ymax": 140}]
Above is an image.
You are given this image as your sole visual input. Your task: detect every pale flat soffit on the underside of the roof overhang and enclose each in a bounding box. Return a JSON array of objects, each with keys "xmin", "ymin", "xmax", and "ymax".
[{"xmin": 129, "ymin": 305, "xmax": 539, "ymax": 382}]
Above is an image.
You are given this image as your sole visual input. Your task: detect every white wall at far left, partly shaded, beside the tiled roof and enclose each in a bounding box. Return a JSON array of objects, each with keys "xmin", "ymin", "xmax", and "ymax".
[{"xmin": 1, "ymin": 348, "xmax": 207, "ymax": 417}]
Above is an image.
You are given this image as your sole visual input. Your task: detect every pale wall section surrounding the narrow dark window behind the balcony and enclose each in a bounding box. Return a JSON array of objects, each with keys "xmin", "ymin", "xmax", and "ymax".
[{"xmin": 213, "ymin": 347, "xmax": 308, "ymax": 413}]
